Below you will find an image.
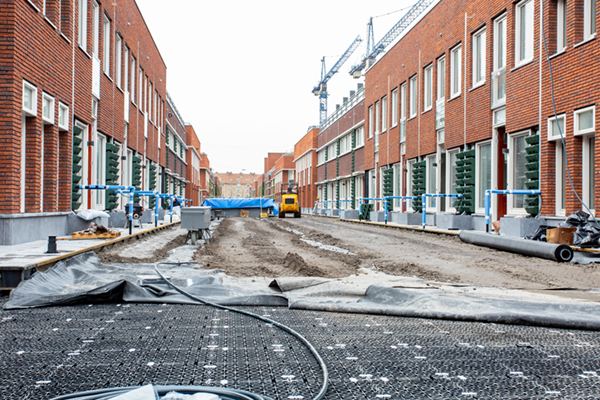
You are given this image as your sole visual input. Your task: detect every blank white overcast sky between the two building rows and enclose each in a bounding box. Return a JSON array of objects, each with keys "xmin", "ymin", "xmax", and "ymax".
[{"xmin": 137, "ymin": 0, "xmax": 415, "ymax": 173}]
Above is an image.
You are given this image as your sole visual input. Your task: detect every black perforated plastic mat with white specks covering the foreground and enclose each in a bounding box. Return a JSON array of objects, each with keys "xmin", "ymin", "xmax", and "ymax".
[{"xmin": 0, "ymin": 299, "xmax": 600, "ymax": 400}]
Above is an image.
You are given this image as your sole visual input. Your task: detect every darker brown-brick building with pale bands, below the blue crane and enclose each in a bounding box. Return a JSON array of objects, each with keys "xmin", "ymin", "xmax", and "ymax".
[{"xmin": 315, "ymin": 84, "xmax": 368, "ymax": 209}]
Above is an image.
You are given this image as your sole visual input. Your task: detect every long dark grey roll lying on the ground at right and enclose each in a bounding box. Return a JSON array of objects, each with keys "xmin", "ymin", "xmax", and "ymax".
[{"xmin": 459, "ymin": 231, "xmax": 573, "ymax": 262}]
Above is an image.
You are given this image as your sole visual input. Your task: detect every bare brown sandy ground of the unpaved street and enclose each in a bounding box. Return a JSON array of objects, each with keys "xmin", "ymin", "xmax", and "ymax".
[{"xmin": 100, "ymin": 216, "xmax": 600, "ymax": 301}]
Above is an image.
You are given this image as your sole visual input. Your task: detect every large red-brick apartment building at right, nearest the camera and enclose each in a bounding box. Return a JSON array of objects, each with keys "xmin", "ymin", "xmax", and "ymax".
[{"xmin": 364, "ymin": 0, "xmax": 600, "ymax": 225}]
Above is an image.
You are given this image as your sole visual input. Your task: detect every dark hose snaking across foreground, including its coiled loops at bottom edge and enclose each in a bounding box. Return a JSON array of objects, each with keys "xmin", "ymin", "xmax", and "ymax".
[{"xmin": 51, "ymin": 262, "xmax": 329, "ymax": 400}]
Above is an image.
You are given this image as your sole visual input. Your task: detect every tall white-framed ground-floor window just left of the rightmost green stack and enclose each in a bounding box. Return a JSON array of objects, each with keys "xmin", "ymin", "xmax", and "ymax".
[{"xmin": 507, "ymin": 131, "xmax": 529, "ymax": 214}]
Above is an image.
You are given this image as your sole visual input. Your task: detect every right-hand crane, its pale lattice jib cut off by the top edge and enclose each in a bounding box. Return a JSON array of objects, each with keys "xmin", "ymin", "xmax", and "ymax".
[{"xmin": 350, "ymin": 0, "xmax": 438, "ymax": 78}]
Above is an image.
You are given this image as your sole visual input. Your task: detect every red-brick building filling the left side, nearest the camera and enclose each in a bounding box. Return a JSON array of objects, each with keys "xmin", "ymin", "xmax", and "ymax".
[{"xmin": 0, "ymin": 0, "xmax": 209, "ymax": 244}]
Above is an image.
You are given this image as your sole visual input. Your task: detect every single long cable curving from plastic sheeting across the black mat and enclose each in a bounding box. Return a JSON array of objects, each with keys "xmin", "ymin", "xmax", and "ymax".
[{"xmin": 154, "ymin": 262, "xmax": 329, "ymax": 400}]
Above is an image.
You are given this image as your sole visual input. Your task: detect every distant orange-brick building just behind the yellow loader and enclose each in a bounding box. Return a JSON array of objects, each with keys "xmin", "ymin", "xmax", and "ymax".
[{"xmin": 294, "ymin": 127, "xmax": 319, "ymax": 212}]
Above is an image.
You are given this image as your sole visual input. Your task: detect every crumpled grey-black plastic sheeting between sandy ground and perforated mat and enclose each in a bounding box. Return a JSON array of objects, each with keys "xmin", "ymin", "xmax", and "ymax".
[{"xmin": 4, "ymin": 253, "xmax": 600, "ymax": 330}]
